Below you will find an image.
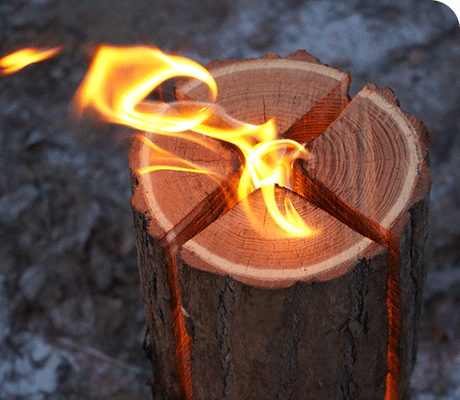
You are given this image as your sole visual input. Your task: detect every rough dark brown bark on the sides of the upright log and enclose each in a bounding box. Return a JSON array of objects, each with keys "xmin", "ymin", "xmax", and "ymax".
[{"xmin": 131, "ymin": 200, "xmax": 427, "ymax": 400}]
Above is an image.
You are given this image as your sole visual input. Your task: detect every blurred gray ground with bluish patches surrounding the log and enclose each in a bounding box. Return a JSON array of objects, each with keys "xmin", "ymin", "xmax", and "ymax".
[{"xmin": 0, "ymin": 0, "xmax": 460, "ymax": 400}]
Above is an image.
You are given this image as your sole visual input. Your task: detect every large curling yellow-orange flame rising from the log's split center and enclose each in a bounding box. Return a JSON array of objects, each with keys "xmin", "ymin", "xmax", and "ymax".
[{"xmin": 75, "ymin": 46, "xmax": 315, "ymax": 237}]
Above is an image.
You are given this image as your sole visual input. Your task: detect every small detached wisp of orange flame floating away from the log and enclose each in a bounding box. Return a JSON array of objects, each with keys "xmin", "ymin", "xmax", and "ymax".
[{"xmin": 0, "ymin": 45, "xmax": 64, "ymax": 75}]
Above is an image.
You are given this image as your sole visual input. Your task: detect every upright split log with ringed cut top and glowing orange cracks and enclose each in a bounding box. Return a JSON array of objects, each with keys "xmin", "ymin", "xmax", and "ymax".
[{"xmin": 130, "ymin": 52, "xmax": 430, "ymax": 400}]
